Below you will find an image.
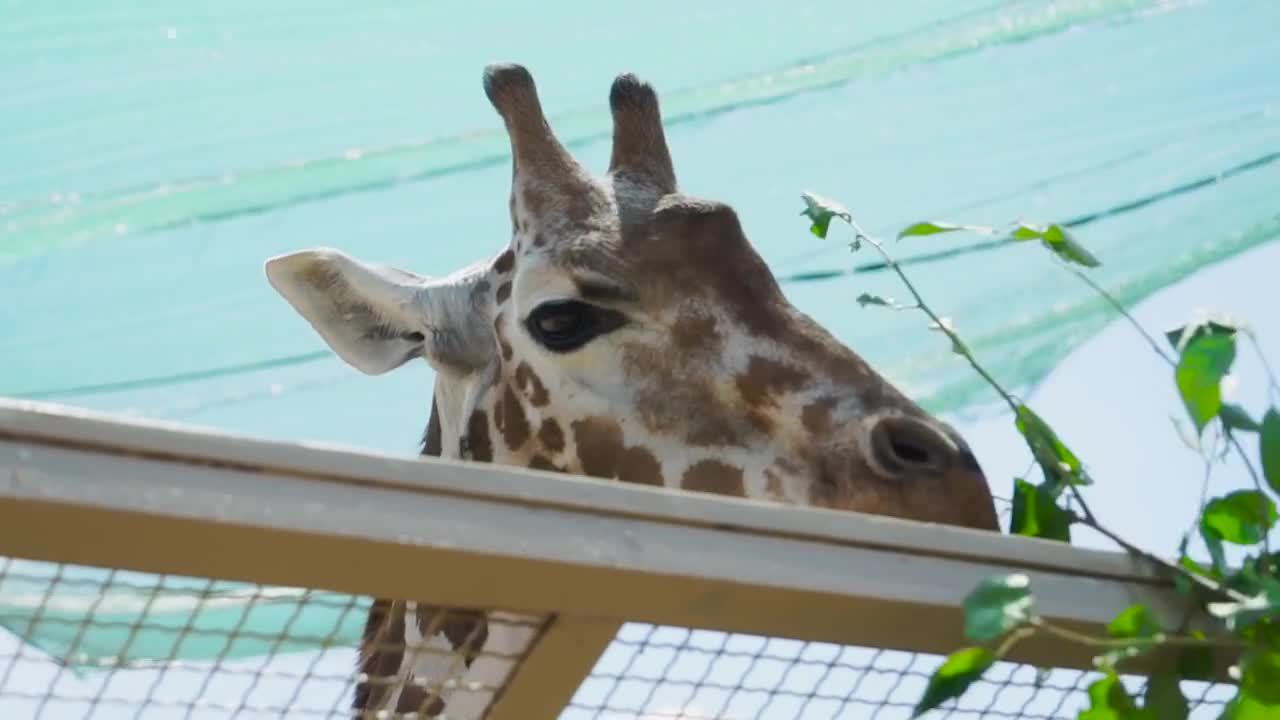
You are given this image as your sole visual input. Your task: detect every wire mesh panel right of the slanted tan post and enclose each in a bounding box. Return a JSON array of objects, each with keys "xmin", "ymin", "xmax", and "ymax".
[{"xmin": 561, "ymin": 624, "xmax": 1234, "ymax": 720}]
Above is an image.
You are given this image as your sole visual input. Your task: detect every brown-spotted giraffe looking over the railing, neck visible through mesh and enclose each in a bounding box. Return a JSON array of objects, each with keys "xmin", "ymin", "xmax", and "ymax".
[{"xmin": 265, "ymin": 64, "xmax": 1000, "ymax": 717}]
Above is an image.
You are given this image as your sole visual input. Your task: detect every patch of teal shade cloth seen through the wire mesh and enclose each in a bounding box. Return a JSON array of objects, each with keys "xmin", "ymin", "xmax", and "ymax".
[{"xmin": 0, "ymin": 560, "xmax": 370, "ymax": 670}]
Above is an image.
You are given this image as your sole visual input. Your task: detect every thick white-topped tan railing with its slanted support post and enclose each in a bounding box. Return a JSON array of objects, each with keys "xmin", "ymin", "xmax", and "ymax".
[{"xmin": 0, "ymin": 401, "xmax": 1239, "ymax": 719}]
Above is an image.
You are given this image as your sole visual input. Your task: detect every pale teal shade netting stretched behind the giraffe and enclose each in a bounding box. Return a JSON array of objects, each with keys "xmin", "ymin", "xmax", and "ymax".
[{"xmin": 0, "ymin": 0, "xmax": 1280, "ymax": 666}]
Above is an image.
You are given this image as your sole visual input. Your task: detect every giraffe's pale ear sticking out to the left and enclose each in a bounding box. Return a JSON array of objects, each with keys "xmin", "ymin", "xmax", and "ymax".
[{"xmin": 266, "ymin": 249, "xmax": 493, "ymax": 375}]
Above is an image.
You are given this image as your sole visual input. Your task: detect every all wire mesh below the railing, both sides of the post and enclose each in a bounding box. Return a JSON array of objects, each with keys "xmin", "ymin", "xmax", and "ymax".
[{"xmin": 0, "ymin": 559, "xmax": 1231, "ymax": 720}]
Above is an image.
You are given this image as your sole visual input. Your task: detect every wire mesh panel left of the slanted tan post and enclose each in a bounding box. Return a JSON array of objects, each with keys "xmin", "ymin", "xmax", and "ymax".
[{"xmin": 0, "ymin": 559, "xmax": 544, "ymax": 720}]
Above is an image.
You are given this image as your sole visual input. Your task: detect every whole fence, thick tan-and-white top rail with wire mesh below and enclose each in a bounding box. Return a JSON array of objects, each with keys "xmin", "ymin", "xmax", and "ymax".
[{"xmin": 0, "ymin": 402, "xmax": 1233, "ymax": 720}]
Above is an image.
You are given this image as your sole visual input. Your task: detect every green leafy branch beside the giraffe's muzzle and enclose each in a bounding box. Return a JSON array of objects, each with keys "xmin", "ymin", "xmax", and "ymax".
[{"xmin": 801, "ymin": 192, "xmax": 1280, "ymax": 720}]
